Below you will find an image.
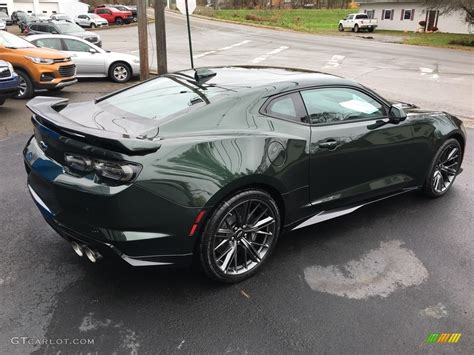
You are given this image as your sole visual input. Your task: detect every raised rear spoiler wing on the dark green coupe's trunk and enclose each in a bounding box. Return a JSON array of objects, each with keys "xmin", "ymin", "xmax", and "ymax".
[{"xmin": 26, "ymin": 96, "xmax": 161, "ymax": 155}]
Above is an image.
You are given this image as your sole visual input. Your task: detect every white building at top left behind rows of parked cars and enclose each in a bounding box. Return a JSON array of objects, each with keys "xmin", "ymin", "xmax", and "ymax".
[{"xmin": 0, "ymin": 0, "xmax": 89, "ymax": 17}]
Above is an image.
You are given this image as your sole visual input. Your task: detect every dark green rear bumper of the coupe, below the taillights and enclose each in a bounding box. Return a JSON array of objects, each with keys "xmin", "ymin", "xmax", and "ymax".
[{"xmin": 23, "ymin": 138, "xmax": 198, "ymax": 266}]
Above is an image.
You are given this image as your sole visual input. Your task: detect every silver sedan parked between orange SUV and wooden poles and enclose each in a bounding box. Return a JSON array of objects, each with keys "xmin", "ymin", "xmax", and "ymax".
[{"xmin": 27, "ymin": 34, "xmax": 140, "ymax": 83}]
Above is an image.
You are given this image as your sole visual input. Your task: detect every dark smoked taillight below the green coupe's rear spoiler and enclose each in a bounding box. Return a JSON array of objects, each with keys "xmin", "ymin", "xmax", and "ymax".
[{"xmin": 64, "ymin": 153, "xmax": 142, "ymax": 183}]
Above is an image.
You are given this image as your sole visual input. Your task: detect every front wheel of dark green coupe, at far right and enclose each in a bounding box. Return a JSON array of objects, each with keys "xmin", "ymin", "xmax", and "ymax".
[{"xmin": 423, "ymin": 138, "xmax": 462, "ymax": 198}]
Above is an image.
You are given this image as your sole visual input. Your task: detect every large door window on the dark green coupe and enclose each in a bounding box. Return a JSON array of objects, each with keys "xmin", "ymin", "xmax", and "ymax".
[{"xmin": 301, "ymin": 88, "xmax": 386, "ymax": 124}]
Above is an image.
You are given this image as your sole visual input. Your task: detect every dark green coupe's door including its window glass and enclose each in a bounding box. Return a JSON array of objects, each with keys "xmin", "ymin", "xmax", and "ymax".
[{"xmin": 302, "ymin": 88, "xmax": 415, "ymax": 208}]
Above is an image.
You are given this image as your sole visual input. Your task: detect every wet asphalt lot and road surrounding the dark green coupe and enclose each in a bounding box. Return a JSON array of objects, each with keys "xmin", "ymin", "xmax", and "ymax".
[{"xmin": 0, "ymin": 14, "xmax": 474, "ymax": 354}]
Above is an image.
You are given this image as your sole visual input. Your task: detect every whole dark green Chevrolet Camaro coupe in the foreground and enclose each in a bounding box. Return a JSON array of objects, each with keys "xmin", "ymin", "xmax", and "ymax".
[{"xmin": 24, "ymin": 67, "xmax": 466, "ymax": 283}]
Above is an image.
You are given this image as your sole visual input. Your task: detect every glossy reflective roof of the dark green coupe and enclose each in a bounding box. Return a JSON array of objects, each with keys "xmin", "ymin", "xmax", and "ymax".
[{"xmin": 181, "ymin": 65, "xmax": 360, "ymax": 95}]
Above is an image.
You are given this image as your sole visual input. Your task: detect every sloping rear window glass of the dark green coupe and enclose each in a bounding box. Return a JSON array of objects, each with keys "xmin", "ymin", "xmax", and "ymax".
[{"xmin": 98, "ymin": 77, "xmax": 224, "ymax": 119}]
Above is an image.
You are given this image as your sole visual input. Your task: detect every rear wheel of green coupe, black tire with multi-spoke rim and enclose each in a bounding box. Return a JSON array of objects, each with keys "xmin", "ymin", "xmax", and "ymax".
[{"xmin": 198, "ymin": 189, "xmax": 281, "ymax": 283}]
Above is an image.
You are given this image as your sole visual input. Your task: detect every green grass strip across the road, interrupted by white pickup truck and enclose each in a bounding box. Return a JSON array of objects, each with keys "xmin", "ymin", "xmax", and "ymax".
[{"xmin": 195, "ymin": 7, "xmax": 474, "ymax": 51}]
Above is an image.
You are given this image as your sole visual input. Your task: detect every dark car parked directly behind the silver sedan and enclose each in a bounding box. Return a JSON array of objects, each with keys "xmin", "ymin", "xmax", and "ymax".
[{"xmin": 25, "ymin": 20, "xmax": 102, "ymax": 47}]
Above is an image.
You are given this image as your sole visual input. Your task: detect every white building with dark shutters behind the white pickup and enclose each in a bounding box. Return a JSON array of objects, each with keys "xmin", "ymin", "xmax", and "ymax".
[{"xmin": 358, "ymin": 0, "xmax": 474, "ymax": 33}]
